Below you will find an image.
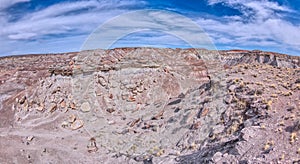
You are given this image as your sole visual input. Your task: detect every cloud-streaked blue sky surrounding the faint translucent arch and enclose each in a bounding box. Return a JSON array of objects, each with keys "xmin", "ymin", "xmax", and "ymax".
[{"xmin": 0, "ymin": 0, "xmax": 300, "ymax": 56}]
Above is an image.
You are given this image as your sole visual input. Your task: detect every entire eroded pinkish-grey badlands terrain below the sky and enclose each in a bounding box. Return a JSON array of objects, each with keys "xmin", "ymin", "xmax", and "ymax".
[{"xmin": 0, "ymin": 48, "xmax": 300, "ymax": 163}]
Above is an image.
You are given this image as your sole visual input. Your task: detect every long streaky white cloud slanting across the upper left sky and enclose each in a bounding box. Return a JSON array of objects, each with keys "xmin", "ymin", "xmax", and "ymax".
[{"xmin": 0, "ymin": 0, "xmax": 145, "ymax": 40}]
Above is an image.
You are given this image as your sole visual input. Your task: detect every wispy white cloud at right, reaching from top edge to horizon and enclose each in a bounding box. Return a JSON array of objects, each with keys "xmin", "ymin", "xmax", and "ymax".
[{"xmin": 204, "ymin": 0, "xmax": 300, "ymax": 52}]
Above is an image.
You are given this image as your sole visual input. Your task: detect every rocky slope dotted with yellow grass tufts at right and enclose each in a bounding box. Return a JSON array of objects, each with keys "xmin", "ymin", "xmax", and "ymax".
[{"xmin": 179, "ymin": 64, "xmax": 300, "ymax": 163}]
